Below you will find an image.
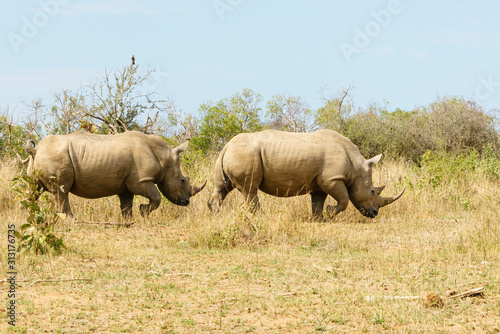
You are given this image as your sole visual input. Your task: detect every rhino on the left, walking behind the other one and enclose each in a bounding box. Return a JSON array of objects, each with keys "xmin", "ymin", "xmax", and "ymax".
[{"xmin": 28, "ymin": 131, "xmax": 206, "ymax": 217}]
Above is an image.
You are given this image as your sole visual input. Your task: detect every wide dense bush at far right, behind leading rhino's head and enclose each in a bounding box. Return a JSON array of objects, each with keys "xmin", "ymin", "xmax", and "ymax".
[{"xmin": 334, "ymin": 97, "xmax": 500, "ymax": 164}]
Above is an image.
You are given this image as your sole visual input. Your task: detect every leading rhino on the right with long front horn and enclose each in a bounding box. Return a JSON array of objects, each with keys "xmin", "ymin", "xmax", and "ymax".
[{"xmin": 208, "ymin": 130, "xmax": 404, "ymax": 219}]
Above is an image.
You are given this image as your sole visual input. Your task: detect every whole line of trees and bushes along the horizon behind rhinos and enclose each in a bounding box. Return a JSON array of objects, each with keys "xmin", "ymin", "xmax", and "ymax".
[{"xmin": 0, "ymin": 65, "xmax": 500, "ymax": 164}]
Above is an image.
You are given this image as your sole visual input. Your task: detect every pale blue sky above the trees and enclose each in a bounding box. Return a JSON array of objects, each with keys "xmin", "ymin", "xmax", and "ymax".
[{"xmin": 0, "ymin": 0, "xmax": 500, "ymax": 120}]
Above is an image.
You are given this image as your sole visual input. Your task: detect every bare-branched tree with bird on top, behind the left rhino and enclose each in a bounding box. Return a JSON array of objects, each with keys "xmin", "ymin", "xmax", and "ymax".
[{"xmin": 26, "ymin": 65, "xmax": 168, "ymax": 136}]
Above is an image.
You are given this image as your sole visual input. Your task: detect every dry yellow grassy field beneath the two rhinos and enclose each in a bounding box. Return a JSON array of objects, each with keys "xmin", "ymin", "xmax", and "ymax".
[{"xmin": 0, "ymin": 155, "xmax": 500, "ymax": 333}]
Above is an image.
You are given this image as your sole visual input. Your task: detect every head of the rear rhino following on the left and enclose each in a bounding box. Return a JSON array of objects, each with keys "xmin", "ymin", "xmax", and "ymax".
[{"xmin": 154, "ymin": 140, "xmax": 207, "ymax": 206}]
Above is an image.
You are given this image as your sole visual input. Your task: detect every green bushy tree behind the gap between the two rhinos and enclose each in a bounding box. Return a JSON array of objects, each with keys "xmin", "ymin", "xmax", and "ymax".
[{"xmin": 192, "ymin": 89, "xmax": 262, "ymax": 152}]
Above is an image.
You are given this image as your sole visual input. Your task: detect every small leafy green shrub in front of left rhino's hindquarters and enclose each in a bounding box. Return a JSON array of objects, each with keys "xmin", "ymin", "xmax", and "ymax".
[{"xmin": 13, "ymin": 175, "xmax": 66, "ymax": 254}]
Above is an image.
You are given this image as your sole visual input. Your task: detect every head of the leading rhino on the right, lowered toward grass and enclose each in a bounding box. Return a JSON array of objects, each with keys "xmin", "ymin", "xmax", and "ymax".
[{"xmin": 347, "ymin": 154, "xmax": 405, "ymax": 218}]
